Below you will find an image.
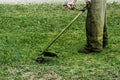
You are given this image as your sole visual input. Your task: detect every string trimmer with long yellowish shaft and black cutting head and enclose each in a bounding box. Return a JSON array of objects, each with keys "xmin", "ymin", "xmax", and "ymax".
[{"xmin": 36, "ymin": 4, "xmax": 88, "ymax": 63}]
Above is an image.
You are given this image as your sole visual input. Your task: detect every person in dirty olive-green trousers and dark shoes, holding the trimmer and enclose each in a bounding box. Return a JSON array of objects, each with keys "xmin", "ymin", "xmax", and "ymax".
[{"xmin": 67, "ymin": 0, "xmax": 108, "ymax": 53}]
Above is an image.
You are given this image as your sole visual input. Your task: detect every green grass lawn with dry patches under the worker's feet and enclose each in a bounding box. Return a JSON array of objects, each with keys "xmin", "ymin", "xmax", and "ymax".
[{"xmin": 0, "ymin": 2, "xmax": 120, "ymax": 80}]
